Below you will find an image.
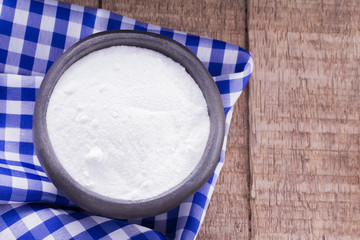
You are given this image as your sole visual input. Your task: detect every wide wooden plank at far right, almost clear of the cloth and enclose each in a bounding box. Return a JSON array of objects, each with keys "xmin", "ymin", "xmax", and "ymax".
[{"xmin": 249, "ymin": 0, "xmax": 360, "ymax": 240}]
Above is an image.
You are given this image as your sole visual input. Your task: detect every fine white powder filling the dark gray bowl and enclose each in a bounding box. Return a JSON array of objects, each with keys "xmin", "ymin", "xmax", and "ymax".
[{"xmin": 47, "ymin": 46, "xmax": 210, "ymax": 200}]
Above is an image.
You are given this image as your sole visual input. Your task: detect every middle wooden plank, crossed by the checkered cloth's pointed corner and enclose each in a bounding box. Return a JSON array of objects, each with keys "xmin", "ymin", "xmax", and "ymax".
[{"xmin": 102, "ymin": 0, "xmax": 249, "ymax": 239}]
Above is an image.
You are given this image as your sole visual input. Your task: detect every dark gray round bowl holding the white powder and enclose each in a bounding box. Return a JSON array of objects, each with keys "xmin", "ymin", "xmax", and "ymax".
[{"xmin": 33, "ymin": 31, "xmax": 225, "ymax": 218}]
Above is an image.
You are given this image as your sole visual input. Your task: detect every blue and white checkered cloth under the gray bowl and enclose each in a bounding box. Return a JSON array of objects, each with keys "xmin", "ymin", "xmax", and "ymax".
[{"xmin": 0, "ymin": 0, "xmax": 253, "ymax": 240}]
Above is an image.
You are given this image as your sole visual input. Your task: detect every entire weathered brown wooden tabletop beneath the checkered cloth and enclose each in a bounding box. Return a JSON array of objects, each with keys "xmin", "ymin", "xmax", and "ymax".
[{"xmin": 67, "ymin": 0, "xmax": 360, "ymax": 240}]
